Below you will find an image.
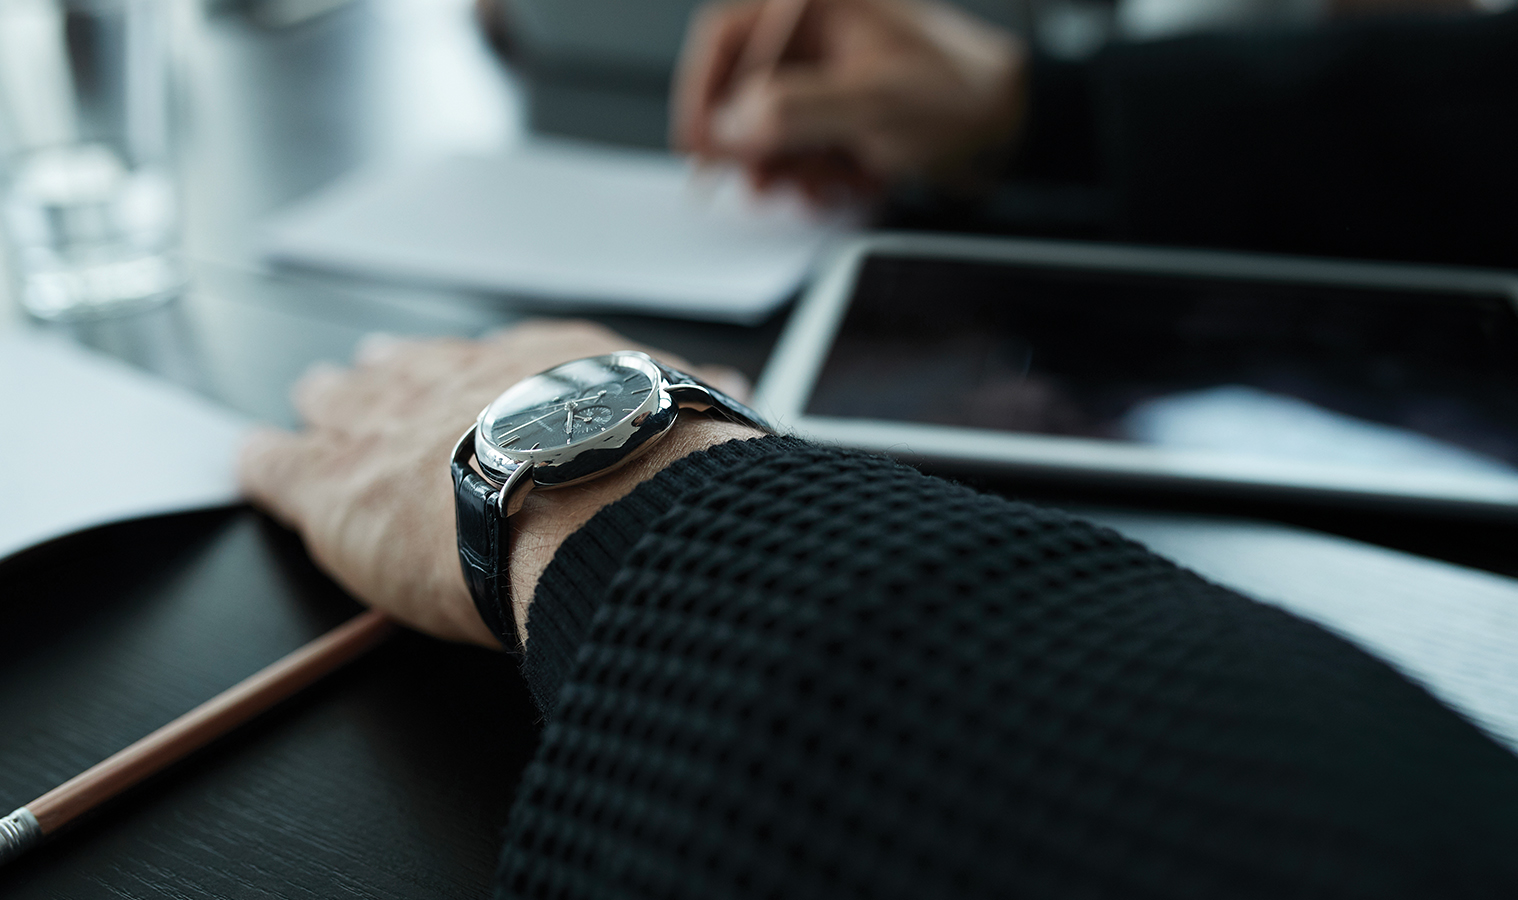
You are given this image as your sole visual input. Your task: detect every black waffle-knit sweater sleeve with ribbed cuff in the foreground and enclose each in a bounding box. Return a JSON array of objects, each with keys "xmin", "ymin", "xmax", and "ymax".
[{"xmin": 498, "ymin": 439, "xmax": 1518, "ymax": 900}]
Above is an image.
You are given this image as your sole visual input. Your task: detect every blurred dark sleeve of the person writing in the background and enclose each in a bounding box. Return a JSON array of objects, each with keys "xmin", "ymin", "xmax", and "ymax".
[{"xmin": 1014, "ymin": 12, "xmax": 1518, "ymax": 267}]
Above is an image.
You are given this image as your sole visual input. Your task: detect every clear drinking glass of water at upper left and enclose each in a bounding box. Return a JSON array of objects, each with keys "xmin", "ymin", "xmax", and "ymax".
[{"xmin": 0, "ymin": 0, "xmax": 185, "ymax": 320}]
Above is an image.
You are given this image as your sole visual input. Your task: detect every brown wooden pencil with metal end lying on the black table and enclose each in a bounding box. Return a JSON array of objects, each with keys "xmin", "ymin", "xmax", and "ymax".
[{"xmin": 0, "ymin": 610, "xmax": 395, "ymax": 864}]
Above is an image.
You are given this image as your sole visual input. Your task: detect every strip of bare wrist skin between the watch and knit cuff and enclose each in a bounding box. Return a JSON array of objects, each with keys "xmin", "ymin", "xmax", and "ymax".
[{"xmin": 507, "ymin": 411, "xmax": 764, "ymax": 640}]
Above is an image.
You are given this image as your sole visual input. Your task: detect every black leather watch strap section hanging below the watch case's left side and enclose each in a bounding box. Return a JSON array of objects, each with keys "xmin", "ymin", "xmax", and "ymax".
[{"xmin": 451, "ymin": 440, "xmax": 522, "ymax": 651}]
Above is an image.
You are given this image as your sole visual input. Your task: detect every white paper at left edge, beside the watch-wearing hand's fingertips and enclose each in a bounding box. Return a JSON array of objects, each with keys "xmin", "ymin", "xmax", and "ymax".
[{"xmin": 0, "ymin": 331, "xmax": 250, "ymax": 559}]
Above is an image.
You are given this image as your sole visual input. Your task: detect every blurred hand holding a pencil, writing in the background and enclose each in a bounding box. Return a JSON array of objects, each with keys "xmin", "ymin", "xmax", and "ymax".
[{"xmin": 671, "ymin": 0, "xmax": 1026, "ymax": 197}]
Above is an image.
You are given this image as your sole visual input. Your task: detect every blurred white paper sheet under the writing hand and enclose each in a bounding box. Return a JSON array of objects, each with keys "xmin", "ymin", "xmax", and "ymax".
[{"xmin": 266, "ymin": 143, "xmax": 855, "ymax": 322}]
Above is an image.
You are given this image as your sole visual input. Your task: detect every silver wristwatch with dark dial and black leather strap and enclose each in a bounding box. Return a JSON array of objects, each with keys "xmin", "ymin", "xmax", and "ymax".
[{"xmin": 451, "ymin": 351, "xmax": 770, "ymax": 651}]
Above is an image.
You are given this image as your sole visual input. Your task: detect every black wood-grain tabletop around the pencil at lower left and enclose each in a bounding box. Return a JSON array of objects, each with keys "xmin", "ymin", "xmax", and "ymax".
[{"xmin": 0, "ymin": 508, "xmax": 537, "ymax": 900}]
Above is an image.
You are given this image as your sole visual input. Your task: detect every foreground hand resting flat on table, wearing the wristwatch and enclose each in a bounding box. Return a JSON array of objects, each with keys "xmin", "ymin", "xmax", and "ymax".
[{"xmin": 240, "ymin": 322, "xmax": 757, "ymax": 648}]
